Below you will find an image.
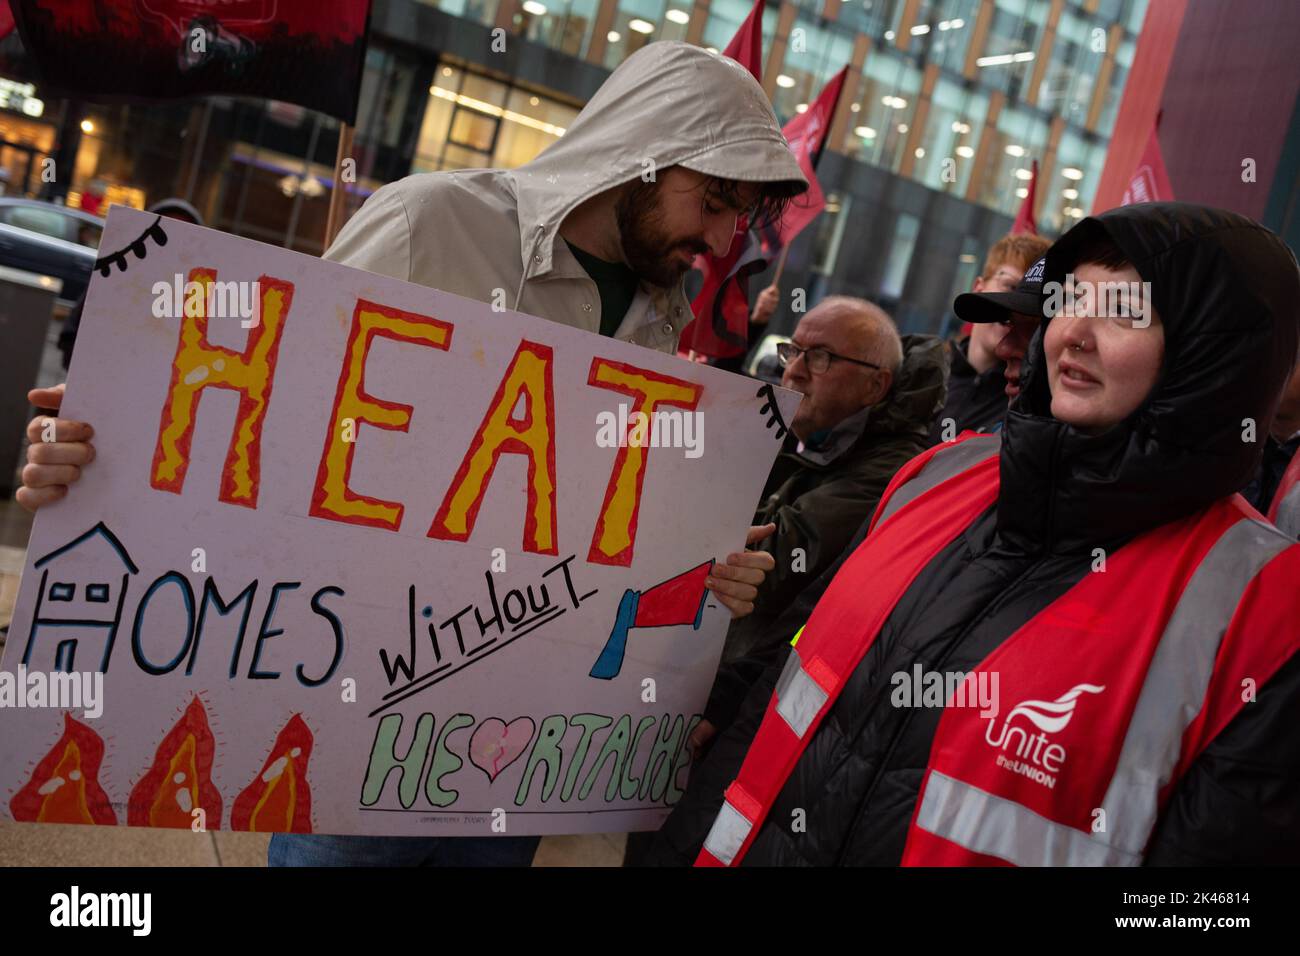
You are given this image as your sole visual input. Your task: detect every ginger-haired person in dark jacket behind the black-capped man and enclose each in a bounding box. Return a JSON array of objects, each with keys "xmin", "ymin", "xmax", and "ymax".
[{"xmin": 930, "ymin": 233, "xmax": 1052, "ymax": 445}]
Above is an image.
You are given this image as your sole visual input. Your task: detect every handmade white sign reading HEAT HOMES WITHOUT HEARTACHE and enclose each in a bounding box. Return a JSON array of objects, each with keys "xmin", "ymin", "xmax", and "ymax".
[{"xmin": 0, "ymin": 208, "xmax": 798, "ymax": 835}]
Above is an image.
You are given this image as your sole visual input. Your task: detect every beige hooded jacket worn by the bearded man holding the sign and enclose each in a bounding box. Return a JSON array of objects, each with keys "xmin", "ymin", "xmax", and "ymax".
[{"xmin": 325, "ymin": 42, "xmax": 807, "ymax": 352}]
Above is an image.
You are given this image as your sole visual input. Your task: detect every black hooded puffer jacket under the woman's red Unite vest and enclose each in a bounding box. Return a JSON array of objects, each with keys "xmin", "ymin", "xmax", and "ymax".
[{"xmin": 647, "ymin": 203, "xmax": 1300, "ymax": 865}]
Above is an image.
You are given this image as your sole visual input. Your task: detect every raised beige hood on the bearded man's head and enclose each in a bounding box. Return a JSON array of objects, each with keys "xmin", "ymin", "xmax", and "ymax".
[{"xmin": 511, "ymin": 42, "xmax": 807, "ymax": 276}]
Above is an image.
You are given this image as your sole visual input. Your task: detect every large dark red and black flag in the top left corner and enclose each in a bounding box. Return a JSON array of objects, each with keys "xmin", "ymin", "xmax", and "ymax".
[{"xmin": 9, "ymin": 0, "xmax": 371, "ymax": 124}]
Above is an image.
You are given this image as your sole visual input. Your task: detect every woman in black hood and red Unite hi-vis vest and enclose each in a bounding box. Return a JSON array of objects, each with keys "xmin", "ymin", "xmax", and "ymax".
[{"xmin": 647, "ymin": 203, "xmax": 1300, "ymax": 866}]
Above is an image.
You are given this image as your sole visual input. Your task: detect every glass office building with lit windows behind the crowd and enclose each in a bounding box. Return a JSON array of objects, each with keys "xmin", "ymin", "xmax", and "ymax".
[{"xmin": 0, "ymin": 0, "xmax": 1147, "ymax": 332}]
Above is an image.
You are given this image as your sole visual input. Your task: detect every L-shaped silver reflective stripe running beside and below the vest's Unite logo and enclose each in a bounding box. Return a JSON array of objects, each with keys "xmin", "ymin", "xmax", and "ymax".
[{"xmin": 917, "ymin": 518, "xmax": 1295, "ymax": 866}]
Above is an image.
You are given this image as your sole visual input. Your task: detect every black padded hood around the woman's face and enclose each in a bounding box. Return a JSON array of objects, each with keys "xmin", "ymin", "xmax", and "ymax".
[{"xmin": 998, "ymin": 203, "xmax": 1300, "ymax": 550}]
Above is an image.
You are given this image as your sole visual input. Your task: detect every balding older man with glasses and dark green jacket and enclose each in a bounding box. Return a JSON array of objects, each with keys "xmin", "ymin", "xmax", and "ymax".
[{"xmin": 723, "ymin": 295, "xmax": 944, "ymax": 661}]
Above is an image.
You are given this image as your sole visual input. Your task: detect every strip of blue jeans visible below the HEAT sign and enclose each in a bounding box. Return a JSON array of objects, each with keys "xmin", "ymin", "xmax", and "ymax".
[{"xmin": 267, "ymin": 834, "xmax": 542, "ymax": 866}]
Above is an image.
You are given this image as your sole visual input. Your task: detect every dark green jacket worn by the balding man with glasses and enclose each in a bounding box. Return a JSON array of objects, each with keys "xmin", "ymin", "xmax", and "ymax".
[{"xmin": 723, "ymin": 336, "xmax": 946, "ymax": 663}]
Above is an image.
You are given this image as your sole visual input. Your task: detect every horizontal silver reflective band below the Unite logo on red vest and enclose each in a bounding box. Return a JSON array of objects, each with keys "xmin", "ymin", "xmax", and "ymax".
[{"xmin": 917, "ymin": 771, "xmax": 1141, "ymax": 866}]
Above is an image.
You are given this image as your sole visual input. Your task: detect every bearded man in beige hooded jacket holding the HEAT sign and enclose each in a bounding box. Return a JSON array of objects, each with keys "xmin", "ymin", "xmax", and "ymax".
[{"xmin": 17, "ymin": 43, "xmax": 806, "ymax": 865}]
